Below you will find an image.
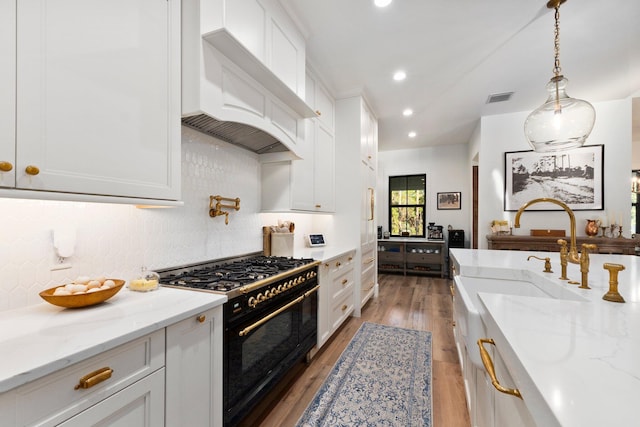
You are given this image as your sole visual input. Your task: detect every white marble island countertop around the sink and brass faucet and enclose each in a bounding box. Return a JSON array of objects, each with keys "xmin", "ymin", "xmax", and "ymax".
[{"xmin": 451, "ymin": 249, "xmax": 640, "ymax": 427}]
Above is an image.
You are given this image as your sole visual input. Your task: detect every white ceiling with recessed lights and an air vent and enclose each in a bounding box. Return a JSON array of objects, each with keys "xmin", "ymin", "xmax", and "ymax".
[{"xmin": 281, "ymin": 0, "xmax": 640, "ymax": 151}]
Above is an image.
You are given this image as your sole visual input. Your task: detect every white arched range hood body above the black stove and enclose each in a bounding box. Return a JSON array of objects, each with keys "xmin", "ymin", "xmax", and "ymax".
[{"xmin": 182, "ymin": 8, "xmax": 315, "ymax": 159}]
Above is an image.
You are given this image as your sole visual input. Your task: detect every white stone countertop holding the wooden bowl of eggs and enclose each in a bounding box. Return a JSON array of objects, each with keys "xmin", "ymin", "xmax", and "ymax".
[{"xmin": 0, "ymin": 285, "xmax": 227, "ymax": 393}]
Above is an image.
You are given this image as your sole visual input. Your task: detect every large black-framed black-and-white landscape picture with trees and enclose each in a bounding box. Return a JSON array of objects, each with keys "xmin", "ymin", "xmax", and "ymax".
[{"xmin": 504, "ymin": 145, "xmax": 604, "ymax": 212}]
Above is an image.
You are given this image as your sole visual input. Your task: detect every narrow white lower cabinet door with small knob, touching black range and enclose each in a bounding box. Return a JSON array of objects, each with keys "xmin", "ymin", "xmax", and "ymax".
[{"xmin": 166, "ymin": 307, "xmax": 223, "ymax": 427}]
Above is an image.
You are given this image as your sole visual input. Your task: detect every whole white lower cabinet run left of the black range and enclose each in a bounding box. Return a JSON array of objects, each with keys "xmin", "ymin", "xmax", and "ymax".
[{"xmin": 0, "ymin": 306, "xmax": 223, "ymax": 427}]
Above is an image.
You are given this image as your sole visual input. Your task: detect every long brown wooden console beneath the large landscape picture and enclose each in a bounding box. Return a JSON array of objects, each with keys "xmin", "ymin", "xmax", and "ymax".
[{"xmin": 487, "ymin": 234, "xmax": 640, "ymax": 255}]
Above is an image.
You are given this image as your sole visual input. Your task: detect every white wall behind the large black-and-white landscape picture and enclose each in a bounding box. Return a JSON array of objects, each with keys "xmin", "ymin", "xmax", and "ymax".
[{"xmin": 478, "ymin": 99, "xmax": 631, "ymax": 248}]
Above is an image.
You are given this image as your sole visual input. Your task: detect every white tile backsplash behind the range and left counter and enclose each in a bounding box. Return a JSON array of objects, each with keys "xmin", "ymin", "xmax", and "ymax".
[{"xmin": 0, "ymin": 128, "xmax": 262, "ymax": 311}]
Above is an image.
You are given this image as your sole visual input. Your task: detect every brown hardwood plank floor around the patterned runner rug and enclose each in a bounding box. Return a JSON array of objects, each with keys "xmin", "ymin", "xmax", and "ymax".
[{"xmin": 242, "ymin": 274, "xmax": 470, "ymax": 427}]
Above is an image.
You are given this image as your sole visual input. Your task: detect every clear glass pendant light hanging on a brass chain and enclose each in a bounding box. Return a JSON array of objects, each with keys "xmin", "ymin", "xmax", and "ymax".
[{"xmin": 524, "ymin": 0, "xmax": 596, "ymax": 152}]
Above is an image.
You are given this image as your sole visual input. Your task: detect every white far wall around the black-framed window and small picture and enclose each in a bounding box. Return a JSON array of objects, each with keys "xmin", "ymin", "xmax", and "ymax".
[{"xmin": 377, "ymin": 144, "xmax": 471, "ymax": 244}]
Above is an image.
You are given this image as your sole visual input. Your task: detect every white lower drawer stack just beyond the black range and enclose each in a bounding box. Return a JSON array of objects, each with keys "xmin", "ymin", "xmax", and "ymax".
[{"xmin": 317, "ymin": 250, "xmax": 355, "ymax": 349}]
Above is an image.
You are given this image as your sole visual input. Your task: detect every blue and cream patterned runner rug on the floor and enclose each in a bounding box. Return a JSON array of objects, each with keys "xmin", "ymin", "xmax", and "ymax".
[{"xmin": 297, "ymin": 322, "xmax": 432, "ymax": 427}]
